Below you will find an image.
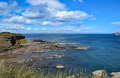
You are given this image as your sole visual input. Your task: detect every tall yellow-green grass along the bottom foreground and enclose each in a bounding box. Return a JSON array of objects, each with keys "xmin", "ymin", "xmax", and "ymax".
[{"xmin": 0, "ymin": 62, "xmax": 109, "ymax": 78}]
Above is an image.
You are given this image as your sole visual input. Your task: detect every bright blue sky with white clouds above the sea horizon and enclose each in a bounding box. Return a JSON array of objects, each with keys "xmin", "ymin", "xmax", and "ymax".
[{"xmin": 0, "ymin": 0, "xmax": 120, "ymax": 33}]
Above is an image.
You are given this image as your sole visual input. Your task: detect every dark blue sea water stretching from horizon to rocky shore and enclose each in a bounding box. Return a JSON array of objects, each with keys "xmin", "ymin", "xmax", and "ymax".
[{"xmin": 24, "ymin": 34, "xmax": 120, "ymax": 73}]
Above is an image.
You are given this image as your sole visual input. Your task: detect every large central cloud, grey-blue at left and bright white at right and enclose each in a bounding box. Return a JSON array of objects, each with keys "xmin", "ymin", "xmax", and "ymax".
[{"xmin": 22, "ymin": 4, "xmax": 95, "ymax": 25}]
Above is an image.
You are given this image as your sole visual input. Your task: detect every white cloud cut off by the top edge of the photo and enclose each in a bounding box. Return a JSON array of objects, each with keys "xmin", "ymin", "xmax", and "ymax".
[{"xmin": 26, "ymin": 0, "xmax": 65, "ymax": 9}]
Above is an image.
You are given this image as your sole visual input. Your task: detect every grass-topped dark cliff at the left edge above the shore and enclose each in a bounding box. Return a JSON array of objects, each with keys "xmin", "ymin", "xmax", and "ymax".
[{"xmin": 0, "ymin": 32, "xmax": 28, "ymax": 51}]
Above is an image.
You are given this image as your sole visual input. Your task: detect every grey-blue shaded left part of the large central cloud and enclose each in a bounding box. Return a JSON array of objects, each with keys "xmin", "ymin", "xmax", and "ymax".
[{"xmin": 22, "ymin": 4, "xmax": 49, "ymax": 19}]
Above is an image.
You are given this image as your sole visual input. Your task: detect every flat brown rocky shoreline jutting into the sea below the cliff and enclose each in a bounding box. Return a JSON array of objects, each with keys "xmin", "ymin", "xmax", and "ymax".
[{"xmin": 0, "ymin": 41, "xmax": 78, "ymax": 63}]
